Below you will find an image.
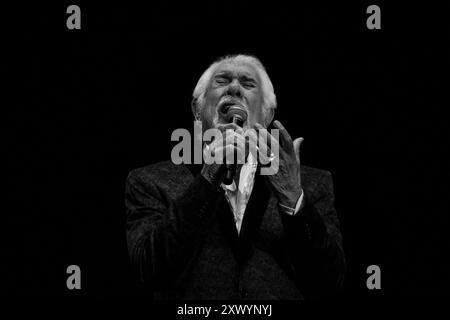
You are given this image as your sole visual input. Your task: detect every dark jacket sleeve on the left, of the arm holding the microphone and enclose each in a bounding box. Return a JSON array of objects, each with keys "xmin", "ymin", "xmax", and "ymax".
[{"xmin": 125, "ymin": 172, "xmax": 219, "ymax": 290}]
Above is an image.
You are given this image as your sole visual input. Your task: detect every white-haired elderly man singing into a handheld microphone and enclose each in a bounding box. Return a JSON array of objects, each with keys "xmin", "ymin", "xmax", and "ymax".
[{"xmin": 125, "ymin": 55, "xmax": 345, "ymax": 300}]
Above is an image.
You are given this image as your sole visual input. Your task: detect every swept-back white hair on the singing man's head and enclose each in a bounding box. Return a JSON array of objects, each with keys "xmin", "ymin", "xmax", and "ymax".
[{"xmin": 192, "ymin": 54, "xmax": 277, "ymax": 120}]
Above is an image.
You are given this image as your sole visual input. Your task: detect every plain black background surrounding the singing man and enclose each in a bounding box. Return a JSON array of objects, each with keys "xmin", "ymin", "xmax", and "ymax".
[{"xmin": 2, "ymin": 1, "xmax": 450, "ymax": 298}]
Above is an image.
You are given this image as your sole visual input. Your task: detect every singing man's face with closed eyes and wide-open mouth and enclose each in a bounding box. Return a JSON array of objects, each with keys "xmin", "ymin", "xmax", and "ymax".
[{"xmin": 201, "ymin": 62, "xmax": 265, "ymax": 129}]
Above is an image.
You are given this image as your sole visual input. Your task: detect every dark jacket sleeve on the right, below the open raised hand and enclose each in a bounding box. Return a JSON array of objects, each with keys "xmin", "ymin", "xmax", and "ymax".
[{"xmin": 280, "ymin": 172, "xmax": 346, "ymax": 298}]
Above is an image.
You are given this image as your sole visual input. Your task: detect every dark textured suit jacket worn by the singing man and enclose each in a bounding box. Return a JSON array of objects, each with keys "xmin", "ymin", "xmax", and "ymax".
[{"xmin": 125, "ymin": 161, "xmax": 345, "ymax": 299}]
